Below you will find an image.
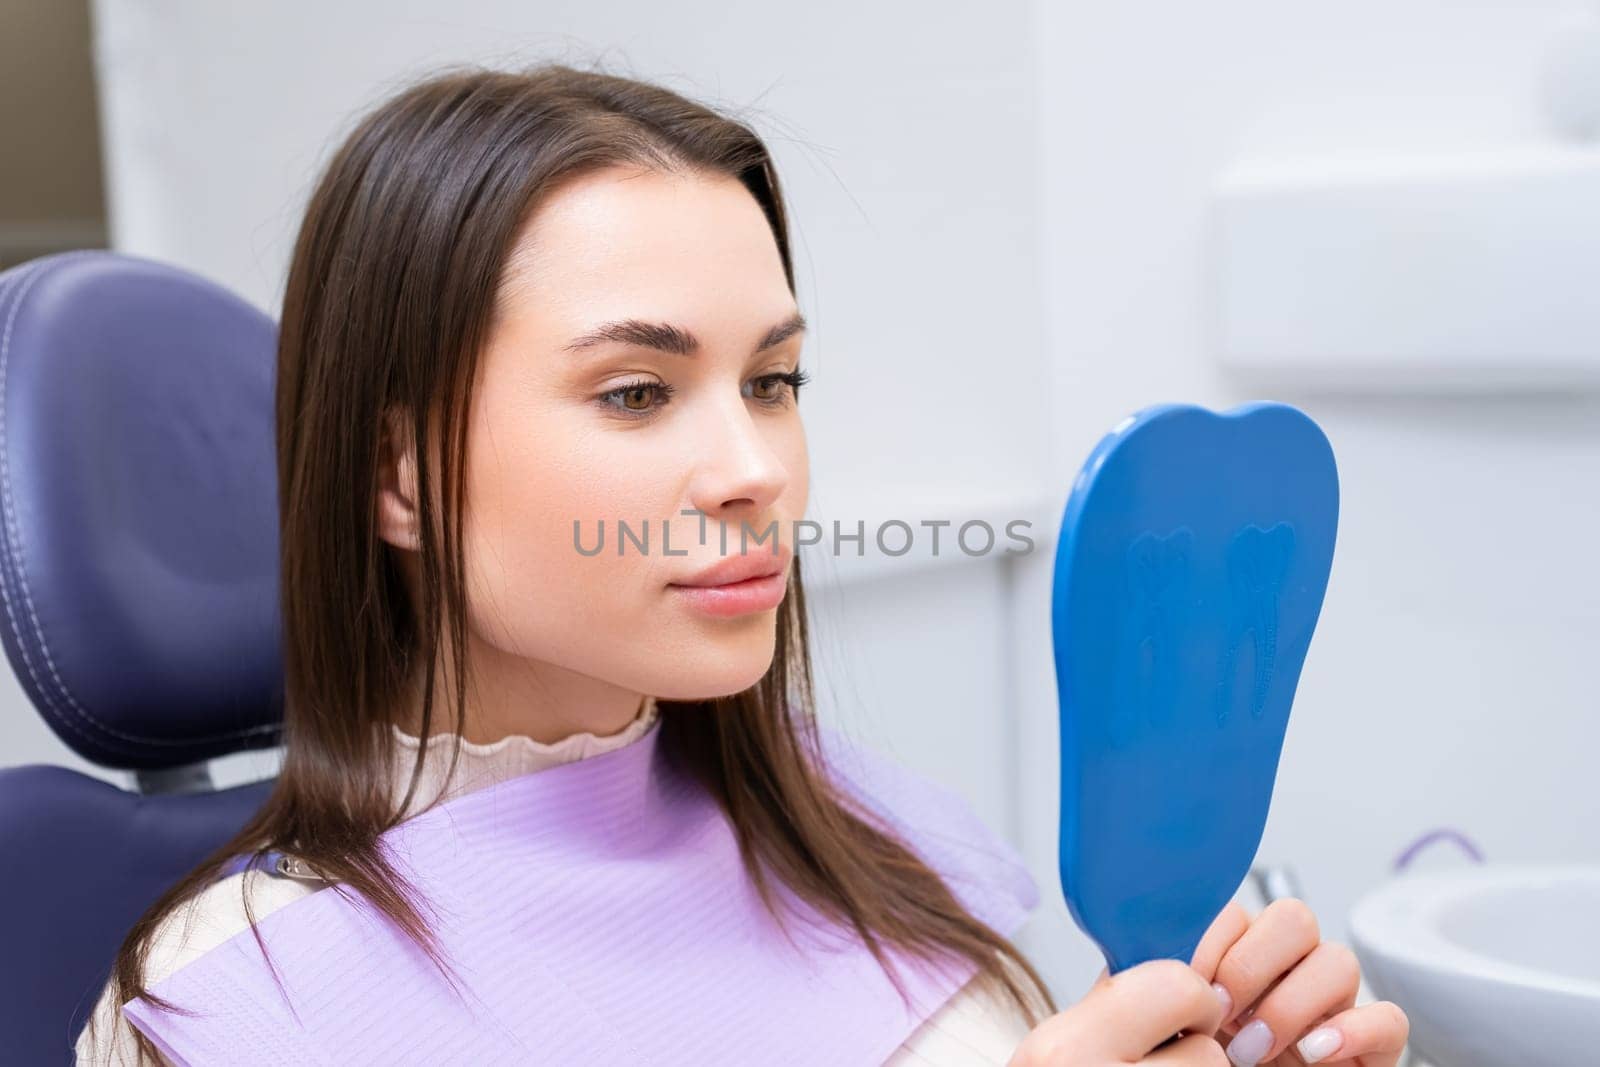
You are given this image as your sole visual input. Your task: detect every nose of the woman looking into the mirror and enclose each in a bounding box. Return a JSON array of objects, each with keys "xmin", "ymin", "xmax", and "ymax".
[{"xmin": 690, "ymin": 397, "xmax": 789, "ymax": 522}]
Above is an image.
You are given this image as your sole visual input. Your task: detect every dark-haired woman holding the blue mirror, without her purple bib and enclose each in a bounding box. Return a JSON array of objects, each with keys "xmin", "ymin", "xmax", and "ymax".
[{"xmin": 78, "ymin": 66, "xmax": 1403, "ymax": 1067}]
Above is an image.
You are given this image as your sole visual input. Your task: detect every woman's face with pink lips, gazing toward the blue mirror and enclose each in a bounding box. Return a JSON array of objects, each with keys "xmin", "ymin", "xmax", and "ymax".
[{"xmin": 388, "ymin": 168, "xmax": 808, "ymax": 716}]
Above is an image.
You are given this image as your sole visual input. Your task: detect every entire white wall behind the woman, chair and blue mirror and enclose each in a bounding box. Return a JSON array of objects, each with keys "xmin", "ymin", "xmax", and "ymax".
[{"xmin": 0, "ymin": 0, "xmax": 1600, "ymax": 1023}]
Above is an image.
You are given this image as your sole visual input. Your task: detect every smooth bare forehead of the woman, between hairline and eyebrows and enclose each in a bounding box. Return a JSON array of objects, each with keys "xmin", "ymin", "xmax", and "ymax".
[{"xmin": 499, "ymin": 168, "xmax": 794, "ymax": 330}]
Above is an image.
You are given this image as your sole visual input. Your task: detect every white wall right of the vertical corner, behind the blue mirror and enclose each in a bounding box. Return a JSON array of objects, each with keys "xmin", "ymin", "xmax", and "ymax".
[{"xmin": 1021, "ymin": 0, "xmax": 1600, "ymax": 989}]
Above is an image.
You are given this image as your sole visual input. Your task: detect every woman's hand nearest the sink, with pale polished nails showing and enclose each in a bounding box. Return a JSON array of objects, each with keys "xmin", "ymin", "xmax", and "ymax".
[{"xmin": 1192, "ymin": 897, "xmax": 1411, "ymax": 1067}]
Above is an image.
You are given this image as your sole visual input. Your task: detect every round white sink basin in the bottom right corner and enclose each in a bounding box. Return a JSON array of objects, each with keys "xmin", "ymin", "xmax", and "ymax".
[{"xmin": 1349, "ymin": 864, "xmax": 1600, "ymax": 1067}]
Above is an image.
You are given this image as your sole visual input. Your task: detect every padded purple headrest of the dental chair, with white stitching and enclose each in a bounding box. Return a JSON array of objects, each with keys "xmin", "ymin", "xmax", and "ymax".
[{"xmin": 0, "ymin": 251, "xmax": 283, "ymax": 769}]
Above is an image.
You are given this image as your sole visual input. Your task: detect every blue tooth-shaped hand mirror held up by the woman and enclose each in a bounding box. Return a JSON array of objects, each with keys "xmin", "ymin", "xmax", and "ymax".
[{"xmin": 1051, "ymin": 403, "xmax": 1339, "ymax": 974}]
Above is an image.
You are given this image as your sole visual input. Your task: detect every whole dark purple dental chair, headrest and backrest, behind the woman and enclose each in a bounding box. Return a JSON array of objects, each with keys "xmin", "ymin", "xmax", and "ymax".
[{"xmin": 0, "ymin": 251, "xmax": 283, "ymax": 1064}]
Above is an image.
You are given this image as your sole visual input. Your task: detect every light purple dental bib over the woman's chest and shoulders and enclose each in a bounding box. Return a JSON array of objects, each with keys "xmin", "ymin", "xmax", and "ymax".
[{"xmin": 125, "ymin": 721, "xmax": 1038, "ymax": 1067}]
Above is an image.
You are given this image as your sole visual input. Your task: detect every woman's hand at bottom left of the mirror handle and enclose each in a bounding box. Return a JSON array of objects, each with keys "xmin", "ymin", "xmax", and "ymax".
[{"xmin": 1006, "ymin": 960, "xmax": 1227, "ymax": 1067}]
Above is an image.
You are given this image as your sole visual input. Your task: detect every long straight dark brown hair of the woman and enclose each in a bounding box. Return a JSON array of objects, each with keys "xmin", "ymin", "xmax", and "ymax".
[{"xmin": 96, "ymin": 64, "xmax": 1054, "ymax": 1059}]
